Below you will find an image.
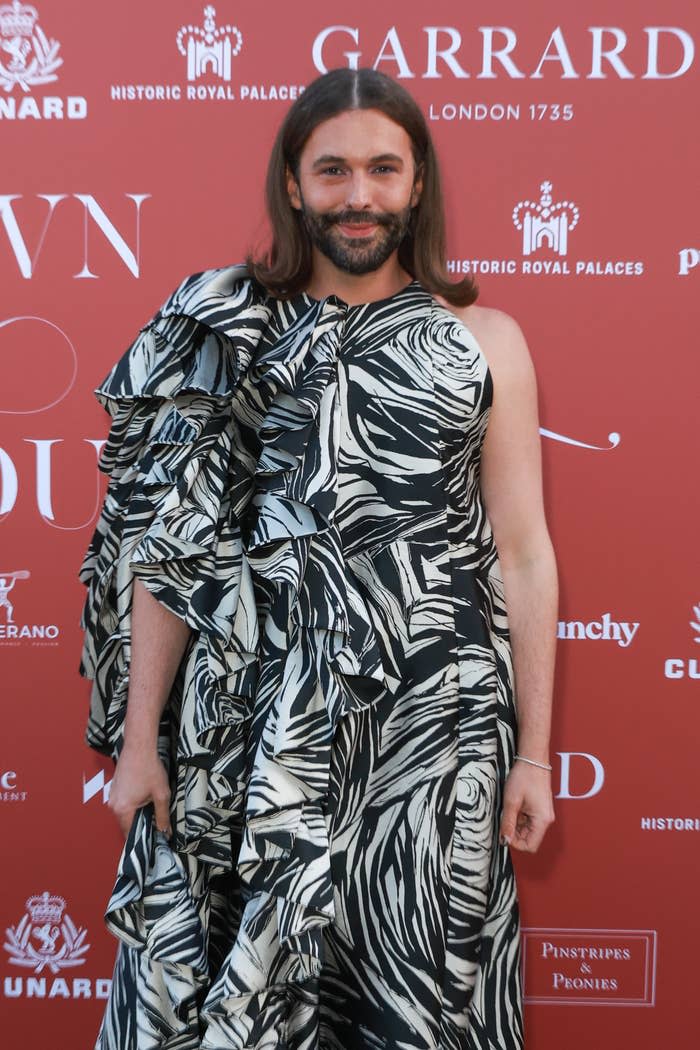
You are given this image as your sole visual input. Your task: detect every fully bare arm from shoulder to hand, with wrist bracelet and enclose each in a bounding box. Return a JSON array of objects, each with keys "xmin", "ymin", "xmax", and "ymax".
[{"xmin": 465, "ymin": 310, "xmax": 558, "ymax": 852}]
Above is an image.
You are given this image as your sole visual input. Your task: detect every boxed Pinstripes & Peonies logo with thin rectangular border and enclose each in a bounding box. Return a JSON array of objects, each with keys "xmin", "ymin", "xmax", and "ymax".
[{"xmin": 523, "ymin": 927, "xmax": 656, "ymax": 1006}]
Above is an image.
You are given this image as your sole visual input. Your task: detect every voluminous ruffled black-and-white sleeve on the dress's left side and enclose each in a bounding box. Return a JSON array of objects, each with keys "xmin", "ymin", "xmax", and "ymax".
[{"xmin": 80, "ymin": 268, "xmax": 268, "ymax": 758}]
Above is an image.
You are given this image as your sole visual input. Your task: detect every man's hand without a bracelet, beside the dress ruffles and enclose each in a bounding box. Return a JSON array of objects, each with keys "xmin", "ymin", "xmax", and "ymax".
[{"xmin": 108, "ymin": 743, "xmax": 171, "ymax": 838}]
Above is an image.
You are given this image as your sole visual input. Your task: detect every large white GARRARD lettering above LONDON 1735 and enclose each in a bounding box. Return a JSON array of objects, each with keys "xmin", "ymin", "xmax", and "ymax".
[{"xmin": 312, "ymin": 25, "xmax": 695, "ymax": 81}]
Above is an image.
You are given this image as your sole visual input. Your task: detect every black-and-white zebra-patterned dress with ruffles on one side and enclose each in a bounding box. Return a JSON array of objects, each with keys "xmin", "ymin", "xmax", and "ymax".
[{"xmin": 81, "ymin": 267, "xmax": 523, "ymax": 1050}]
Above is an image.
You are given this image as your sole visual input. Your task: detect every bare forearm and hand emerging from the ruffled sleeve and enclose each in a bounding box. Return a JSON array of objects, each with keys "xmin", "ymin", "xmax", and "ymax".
[{"xmin": 109, "ymin": 580, "xmax": 190, "ymax": 836}]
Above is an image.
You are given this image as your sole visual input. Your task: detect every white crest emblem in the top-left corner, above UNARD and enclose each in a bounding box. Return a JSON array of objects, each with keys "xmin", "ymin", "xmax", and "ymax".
[{"xmin": 0, "ymin": 0, "xmax": 63, "ymax": 91}]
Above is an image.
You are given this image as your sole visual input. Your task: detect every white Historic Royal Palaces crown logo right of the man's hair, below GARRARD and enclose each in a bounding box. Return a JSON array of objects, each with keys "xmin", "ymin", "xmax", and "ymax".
[{"xmin": 447, "ymin": 180, "xmax": 644, "ymax": 277}]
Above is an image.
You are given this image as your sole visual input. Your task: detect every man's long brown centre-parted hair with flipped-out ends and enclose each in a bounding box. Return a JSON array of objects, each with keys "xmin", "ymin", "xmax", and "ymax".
[{"xmin": 246, "ymin": 68, "xmax": 479, "ymax": 307}]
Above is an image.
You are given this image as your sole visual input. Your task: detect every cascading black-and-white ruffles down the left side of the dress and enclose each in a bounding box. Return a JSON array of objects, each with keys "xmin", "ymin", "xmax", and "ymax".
[{"xmin": 81, "ymin": 268, "xmax": 398, "ymax": 1050}]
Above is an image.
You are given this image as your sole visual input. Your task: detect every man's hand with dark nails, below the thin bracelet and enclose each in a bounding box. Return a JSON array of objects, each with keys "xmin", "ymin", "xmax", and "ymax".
[{"xmin": 501, "ymin": 761, "xmax": 554, "ymax": 853}]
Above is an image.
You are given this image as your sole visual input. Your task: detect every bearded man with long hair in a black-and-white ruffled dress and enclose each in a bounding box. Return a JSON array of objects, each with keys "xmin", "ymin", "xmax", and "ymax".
[{"xmin": 78, "ymin": 69, "xmax": 556, "ymax": 1050}]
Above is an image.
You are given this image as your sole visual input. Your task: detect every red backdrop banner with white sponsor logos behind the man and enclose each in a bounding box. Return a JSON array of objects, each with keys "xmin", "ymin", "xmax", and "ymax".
[{"xmin": 0, "ymin": 0, "xmax": 700, "ymax": 1050}]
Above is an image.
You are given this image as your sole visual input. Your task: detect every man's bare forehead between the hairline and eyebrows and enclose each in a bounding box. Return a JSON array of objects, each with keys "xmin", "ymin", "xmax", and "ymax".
[{"xmin": 301, "ymin": 109, "xmax": 411, "ymax": 164}]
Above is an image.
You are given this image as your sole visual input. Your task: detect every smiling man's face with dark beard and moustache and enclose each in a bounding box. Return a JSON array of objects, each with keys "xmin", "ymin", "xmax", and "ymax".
[{"xmin": 288, "ymin": 109, "xmax": 421, "ymax": 274}]
